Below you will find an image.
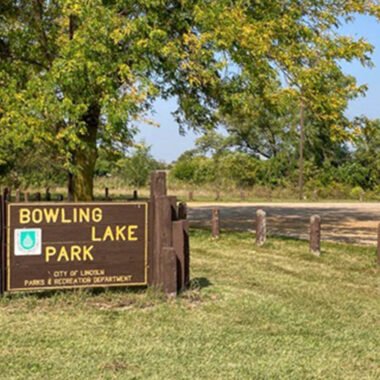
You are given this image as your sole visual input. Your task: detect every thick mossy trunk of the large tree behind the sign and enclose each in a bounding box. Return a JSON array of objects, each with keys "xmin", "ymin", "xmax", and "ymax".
[{"xmin": 68, "ymin": 104, "xmax": 100, "ymax": 201}]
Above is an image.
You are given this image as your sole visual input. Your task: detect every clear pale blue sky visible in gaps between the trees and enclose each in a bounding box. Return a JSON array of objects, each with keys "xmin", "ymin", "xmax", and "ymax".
[{"xmin": 138, "ymin": 16, "xmax": 380, "ymax": 162}]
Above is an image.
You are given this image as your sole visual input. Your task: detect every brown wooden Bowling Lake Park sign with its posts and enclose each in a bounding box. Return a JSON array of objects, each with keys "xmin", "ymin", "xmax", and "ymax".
[{"xmin": 0, "ymin": 171, "xmax": 189, "ymax": 295}]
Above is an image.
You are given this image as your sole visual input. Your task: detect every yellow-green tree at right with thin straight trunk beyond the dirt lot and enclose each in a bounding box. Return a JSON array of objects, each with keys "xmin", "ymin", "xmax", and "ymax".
[{"xmin": 217, "ymin": 1, "xmax": 379, "ymax": 198}]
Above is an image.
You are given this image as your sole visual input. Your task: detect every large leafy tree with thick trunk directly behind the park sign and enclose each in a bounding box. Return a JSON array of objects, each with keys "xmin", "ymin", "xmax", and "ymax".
[{"xmin": 0, "ymin": 0, "xmax": 226, "ymax": 200}]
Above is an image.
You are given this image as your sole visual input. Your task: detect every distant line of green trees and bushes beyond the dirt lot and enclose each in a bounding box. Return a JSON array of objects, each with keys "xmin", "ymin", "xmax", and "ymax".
[{"xmin": 170, "ymin": 118, "xmax": 380, "ymax": 199}]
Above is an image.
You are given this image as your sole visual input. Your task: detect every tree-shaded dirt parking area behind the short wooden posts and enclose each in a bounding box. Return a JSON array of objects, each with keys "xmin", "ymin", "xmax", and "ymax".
[{"xmin": 188, "ymin": 202, "xmax": 380, "ymax": 245}]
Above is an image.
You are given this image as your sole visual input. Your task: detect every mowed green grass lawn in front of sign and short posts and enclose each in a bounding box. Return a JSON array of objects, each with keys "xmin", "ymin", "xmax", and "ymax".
[{"xmin": 0, "ymin": 230, "xmax": 380, "ymax": 379}]
